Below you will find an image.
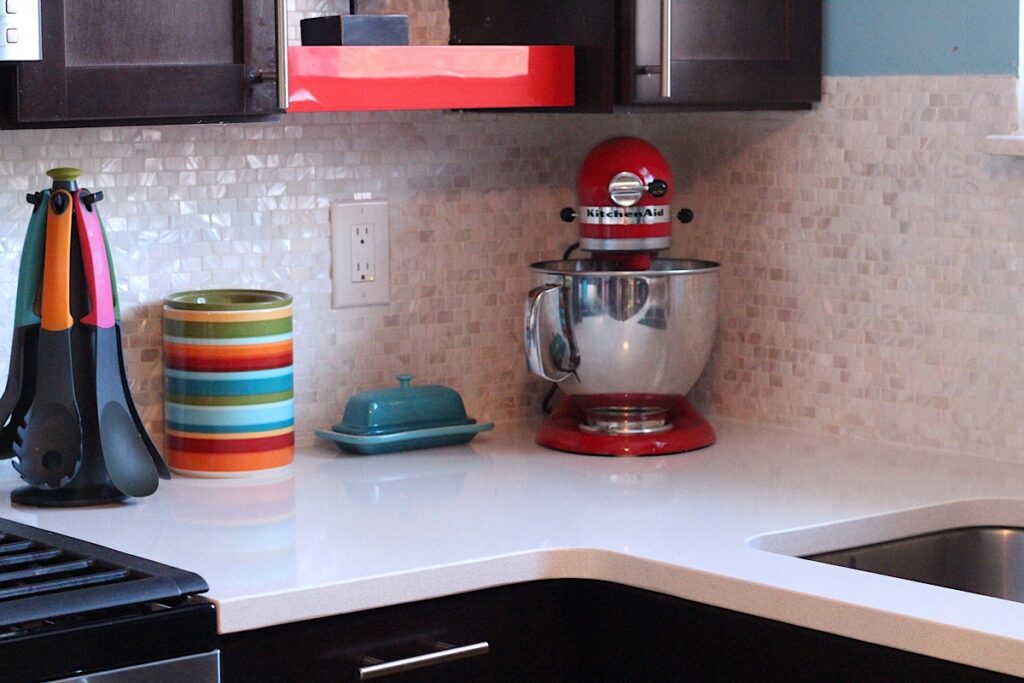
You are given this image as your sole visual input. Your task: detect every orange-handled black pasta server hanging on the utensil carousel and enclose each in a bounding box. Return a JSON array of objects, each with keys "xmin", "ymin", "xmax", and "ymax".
[{"xmin": 14, "ymin": 189, "xmax": 82, "ymax": 489}]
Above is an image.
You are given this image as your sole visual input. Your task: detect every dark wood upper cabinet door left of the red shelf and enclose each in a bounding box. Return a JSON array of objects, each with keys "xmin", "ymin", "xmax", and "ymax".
[{"xmin": 9, "ymin": 0, "xmax": 278, "ymax": 125}]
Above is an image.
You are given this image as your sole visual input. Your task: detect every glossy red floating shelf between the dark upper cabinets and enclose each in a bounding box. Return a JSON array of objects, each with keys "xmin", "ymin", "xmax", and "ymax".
[{"xmin": 288, "ymin": 45, "xmax": 575, "ymax": 112}]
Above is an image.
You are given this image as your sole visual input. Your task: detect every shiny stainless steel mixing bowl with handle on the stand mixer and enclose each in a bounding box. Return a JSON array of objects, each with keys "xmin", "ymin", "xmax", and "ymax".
[{"xmin": 524, "ymin": 259, "xmax": 721, "ymax": 395}]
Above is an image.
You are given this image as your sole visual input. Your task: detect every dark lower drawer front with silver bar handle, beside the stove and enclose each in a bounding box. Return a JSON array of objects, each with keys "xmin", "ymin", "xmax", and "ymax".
[{"xmin": 221, "ymin": 582, "xmax": 566, "ymax": 683}]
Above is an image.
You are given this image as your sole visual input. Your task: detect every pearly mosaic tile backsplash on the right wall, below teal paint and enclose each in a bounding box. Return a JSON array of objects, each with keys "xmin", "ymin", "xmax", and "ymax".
[{"xmin": 688, "ymin": 77, "xmax": 1024, "ymax": 459}]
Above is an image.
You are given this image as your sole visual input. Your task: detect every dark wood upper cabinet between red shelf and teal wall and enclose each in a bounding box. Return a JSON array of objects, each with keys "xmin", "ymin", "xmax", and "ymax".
[{"xmin": 450, "ymin": 0, "xmax": 822, "ymax": 112}]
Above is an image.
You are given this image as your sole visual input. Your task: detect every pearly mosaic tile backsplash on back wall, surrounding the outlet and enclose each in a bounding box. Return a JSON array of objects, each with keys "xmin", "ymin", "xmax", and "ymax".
[{"xmin": 0, "ymin": 113, "xmax": 629, "ymax": 448}]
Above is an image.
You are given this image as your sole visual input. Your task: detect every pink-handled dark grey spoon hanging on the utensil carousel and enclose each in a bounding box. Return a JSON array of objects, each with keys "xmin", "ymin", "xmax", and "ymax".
[{"xmin": 75, "ymin": 190, "xmax": 159, "ymax": 497}]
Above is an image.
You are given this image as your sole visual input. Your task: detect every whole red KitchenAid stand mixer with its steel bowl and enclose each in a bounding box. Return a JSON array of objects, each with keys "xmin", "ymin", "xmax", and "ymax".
[{"xmin": 524, "ymin": 137, "xmax": 720, "ymax": 456}]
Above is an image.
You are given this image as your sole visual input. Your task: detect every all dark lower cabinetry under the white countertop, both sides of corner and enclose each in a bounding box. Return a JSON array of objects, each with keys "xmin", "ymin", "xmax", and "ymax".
[{"xmin": 221, "ymin": 580, "xmax": 1018, "ymax": 683}]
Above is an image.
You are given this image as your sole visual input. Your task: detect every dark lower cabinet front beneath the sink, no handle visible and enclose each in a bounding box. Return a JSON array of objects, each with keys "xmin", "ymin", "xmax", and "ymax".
[{"xmin": 565, "ymin": 581, "xmax": 1019, "ymax": 683}]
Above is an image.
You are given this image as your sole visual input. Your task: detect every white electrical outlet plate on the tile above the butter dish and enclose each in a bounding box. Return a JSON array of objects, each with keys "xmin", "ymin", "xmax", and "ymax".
[{"xmin": 331, "ymin": 202, "xmax": 391, "ymax": 308}]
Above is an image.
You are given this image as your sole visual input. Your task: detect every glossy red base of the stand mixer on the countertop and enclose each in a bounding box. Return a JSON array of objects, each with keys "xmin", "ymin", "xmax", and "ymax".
[{"xmin": 537, "ymin": 396, "xmax": 716, "ymax": 457}]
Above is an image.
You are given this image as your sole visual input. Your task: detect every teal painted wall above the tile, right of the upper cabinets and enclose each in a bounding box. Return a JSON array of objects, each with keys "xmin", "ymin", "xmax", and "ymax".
[{"xmin": 823, "ymin": 0, "xmax": 1020, "ymax": 76}]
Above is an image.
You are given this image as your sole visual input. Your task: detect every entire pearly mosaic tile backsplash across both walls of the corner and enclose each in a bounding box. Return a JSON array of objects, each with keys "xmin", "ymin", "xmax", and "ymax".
[{"xmin": 0, "ymin": 0, "xmax": 1024, "ymax": 458}]
